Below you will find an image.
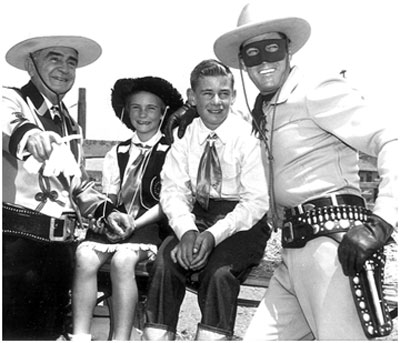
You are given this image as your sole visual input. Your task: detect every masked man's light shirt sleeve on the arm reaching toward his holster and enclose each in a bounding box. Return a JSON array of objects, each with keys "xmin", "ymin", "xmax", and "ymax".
[{"xmin": 307, "ymin": 79, "xmax": 399, "ymax": 226}]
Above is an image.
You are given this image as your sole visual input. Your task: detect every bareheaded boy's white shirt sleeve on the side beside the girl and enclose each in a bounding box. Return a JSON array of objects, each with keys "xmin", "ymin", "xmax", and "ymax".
[{"xmin": 160, "ymin": 133, "xmax": 198, "ymax": 239}]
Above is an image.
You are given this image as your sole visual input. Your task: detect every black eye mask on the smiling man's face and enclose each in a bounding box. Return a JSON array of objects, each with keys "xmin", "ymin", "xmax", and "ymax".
[{"xmin": 240, "ymin": 38, "xmax": 288, "ymax": 67}]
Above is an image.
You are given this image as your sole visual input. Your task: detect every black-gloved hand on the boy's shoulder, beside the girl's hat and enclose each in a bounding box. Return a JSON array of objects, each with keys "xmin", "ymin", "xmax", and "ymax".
[{"xmin": 164, "ymin": 102, "xmax": 199, "ymax": 144}]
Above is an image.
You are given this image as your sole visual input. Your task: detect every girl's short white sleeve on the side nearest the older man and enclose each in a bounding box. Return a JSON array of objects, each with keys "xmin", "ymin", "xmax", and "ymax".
[{"xmin": 101, "ymin": 146, "xmax": 121, "ymax": 194}]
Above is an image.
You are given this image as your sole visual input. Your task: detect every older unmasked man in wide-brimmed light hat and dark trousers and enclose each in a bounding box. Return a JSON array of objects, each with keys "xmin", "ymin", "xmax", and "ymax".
[{"xmin": 2, "ymin": 36, "xmax": 131, "ymax": 340}]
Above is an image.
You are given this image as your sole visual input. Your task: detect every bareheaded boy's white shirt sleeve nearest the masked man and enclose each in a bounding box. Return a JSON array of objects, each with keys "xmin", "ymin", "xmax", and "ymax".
[{"xmin": 208, "ymin": 132, "xmax": 269, "ymax": 245}]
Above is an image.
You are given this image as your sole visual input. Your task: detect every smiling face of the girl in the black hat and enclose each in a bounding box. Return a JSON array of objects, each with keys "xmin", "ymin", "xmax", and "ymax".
[{"xmin": 126, "ymin": 91, "xmax": 165, "ymax": 141}]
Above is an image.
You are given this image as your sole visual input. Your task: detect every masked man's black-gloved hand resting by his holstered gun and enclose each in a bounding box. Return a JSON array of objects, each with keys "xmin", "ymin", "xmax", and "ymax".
[{"xmin": 338, "ymin": 214, "xmax": 393, "ymax": 276}]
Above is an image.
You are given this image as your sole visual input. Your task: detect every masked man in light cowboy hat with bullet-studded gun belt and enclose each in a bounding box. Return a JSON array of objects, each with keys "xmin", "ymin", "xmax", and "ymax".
[{"xmin": 214, "ymin": 4, "xmax": 398, "ymax": 340}]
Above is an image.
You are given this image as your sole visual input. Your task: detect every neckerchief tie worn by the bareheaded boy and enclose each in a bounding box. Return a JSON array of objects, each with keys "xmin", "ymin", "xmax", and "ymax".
[{"xmin": 196, "ymin": 132, "xmax": 222, "ymax": 210}]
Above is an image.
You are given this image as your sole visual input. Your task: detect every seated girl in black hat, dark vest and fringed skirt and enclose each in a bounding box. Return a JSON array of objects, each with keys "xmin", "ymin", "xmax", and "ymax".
[{"xmin": 71, "ymin": 77, "xmax": 183, "ymax": 341}]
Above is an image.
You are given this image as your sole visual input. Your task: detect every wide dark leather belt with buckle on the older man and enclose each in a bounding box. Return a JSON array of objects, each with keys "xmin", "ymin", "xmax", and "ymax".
[{"xmin": 3, "ymin": 202, "xmax": 77, "ymax": 243}]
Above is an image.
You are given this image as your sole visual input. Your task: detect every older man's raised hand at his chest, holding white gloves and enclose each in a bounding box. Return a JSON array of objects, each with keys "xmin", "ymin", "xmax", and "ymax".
[{"xmin": 26, "ymin": 131, "xmax": 62, "ymax": 163}]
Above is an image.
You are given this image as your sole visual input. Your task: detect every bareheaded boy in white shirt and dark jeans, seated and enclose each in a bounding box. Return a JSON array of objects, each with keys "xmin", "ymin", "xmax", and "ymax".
[{"xmin": 143, "ymin": 60, "xmax": 270, "ymax": 340}]
